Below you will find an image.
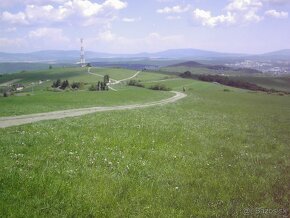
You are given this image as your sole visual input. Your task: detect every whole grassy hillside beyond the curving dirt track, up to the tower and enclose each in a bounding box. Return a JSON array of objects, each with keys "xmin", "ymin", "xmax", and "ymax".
[{"xmin": 0, "ymin": 68, "xmax": 172, "ymax": 117}]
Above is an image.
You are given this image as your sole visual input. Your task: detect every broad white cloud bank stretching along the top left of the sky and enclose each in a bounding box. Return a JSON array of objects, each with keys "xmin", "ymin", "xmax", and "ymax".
[{"xmin": 0, "ymin": 0, "xmax": 127, "ymax": 25}]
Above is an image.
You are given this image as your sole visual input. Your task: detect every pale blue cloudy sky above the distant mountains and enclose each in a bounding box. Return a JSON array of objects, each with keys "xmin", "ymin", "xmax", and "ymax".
[{"xmin": 0, "ymin": 0, "xmax": 290, "ymax": 53}]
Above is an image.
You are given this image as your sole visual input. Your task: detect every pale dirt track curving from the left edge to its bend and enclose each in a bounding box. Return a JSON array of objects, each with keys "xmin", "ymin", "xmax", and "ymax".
[{"xmin": 0, "ymin": 91, "xmax": 186, "ymax": 128}]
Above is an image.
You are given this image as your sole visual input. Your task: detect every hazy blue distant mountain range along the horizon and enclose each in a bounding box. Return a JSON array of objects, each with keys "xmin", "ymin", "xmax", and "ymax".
[{"xmin": 0, "ymin": 49, "xmax": 290, "ymax": 63}]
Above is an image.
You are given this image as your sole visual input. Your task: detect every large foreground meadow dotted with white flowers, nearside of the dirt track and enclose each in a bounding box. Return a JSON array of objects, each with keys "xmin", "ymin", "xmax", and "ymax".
[{"xmin": 0, "ymin": 70, "xmax": 290, "ymax": 217}]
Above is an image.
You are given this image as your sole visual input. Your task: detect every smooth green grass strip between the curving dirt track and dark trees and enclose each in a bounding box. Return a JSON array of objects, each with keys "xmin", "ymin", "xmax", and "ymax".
[{"xmin": 0, "ymin": 87, "xmax": 173, "ymax": 117}]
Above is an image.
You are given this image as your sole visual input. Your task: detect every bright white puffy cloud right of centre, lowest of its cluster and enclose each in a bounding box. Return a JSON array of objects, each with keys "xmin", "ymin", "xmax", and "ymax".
[{"xmin": 193, "ymin": 8, "xmax": 236, "ymax": 27}]
